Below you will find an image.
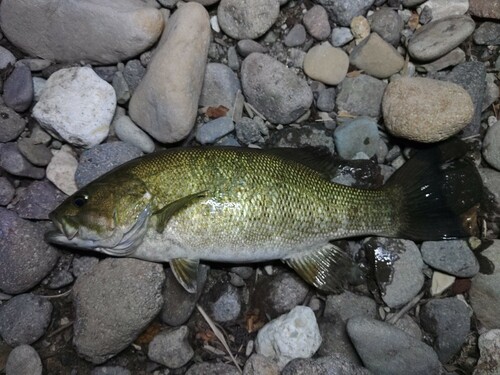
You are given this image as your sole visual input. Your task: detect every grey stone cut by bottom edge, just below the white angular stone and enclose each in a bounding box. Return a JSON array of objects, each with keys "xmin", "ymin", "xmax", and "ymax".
[{"xmin": 281, "ymin": 356, "xmax": 371, "ymax": 375}]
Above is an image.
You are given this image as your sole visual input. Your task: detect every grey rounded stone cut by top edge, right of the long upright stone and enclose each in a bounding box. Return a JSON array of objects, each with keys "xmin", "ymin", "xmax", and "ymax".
[{"xmin": 217, "ymin": 0, "xmax": 280, "ymax": 40}]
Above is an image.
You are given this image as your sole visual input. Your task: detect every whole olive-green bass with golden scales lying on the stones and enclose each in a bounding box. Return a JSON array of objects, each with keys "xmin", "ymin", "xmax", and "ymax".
[{"xmin": 45, "ymin": 141, "xmax": 482, "ymax": 293}]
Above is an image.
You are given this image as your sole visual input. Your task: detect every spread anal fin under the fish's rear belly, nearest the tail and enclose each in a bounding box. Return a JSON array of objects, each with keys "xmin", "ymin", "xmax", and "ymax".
[{"xmin": 283, "ymin": 243, "xmax": 360, "ymax": 292}]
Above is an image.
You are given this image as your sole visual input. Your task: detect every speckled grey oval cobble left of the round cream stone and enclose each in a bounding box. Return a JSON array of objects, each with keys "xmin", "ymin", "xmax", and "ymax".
[{"xmin": 241, "ymin": 53, "xmax": 313, "ymax": 124}]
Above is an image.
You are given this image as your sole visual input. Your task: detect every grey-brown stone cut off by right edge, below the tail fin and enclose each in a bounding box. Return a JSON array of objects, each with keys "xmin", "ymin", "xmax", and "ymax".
[{"xmin": 469, "ymin": 240, "xmax": 500, "ymax": 329}]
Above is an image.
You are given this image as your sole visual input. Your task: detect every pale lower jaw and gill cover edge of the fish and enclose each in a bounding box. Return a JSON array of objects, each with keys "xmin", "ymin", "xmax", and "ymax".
[{"xmin": 45, "ymin": 205, "xmax": 151, "ymax": 256}]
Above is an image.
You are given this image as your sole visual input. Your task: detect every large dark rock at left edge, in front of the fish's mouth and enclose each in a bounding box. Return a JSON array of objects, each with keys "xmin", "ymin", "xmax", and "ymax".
[{"xmin": 0, "ymin": 208, "xmax": 59, "ymax": 294}]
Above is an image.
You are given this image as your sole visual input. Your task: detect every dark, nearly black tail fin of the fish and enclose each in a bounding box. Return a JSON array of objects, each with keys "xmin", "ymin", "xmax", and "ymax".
[{"xmin": 384, "ymin": 139, "xmax": 483, "ymax": 241}]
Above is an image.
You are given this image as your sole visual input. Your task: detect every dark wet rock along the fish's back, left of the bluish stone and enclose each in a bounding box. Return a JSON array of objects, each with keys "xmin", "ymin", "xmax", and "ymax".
[{"xmin": 267, "ymin": 125, "xmax": 335, "ymax": 154}]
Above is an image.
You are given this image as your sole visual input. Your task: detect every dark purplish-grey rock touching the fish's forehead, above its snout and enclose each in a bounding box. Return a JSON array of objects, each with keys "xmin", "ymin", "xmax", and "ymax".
[{"xmin": 14, "ymin": 180, "xmax": 66, "ymax": 220}]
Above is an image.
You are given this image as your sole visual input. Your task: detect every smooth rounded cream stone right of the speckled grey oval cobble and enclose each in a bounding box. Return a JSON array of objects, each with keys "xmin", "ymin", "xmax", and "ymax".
[{"xmin": 304, "ymin": 42, "xmax": 349, "ymax": 85}]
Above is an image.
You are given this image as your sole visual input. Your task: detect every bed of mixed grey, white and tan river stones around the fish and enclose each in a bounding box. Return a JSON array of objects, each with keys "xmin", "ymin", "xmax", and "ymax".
[{"xmin": 0, "ymin": 0, "xmax": 500, "ymax": 375}]
